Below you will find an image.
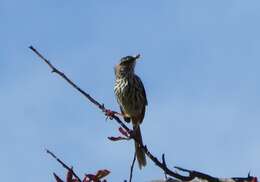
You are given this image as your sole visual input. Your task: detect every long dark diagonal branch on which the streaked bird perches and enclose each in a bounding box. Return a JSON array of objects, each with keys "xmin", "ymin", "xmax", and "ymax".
[{"xmin": 29, "ymin": 46, "xmax": 257, "ymax": 182}]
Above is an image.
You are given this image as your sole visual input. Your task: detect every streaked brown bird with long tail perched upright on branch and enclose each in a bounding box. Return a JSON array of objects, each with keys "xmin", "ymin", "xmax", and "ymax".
[{"xmin": 114, "ymin": 54, "xmax": 148, "ymax": 169}]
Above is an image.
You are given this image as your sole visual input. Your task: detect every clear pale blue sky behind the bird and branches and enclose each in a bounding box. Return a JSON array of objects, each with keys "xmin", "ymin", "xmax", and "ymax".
[{"xmin": 0, "ymin": 0, "xmax": 260, "ymax": 182}]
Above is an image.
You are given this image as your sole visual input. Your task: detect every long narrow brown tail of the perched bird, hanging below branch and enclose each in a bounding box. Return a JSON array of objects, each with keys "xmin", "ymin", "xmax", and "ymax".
[{"xmin": 133, "ymin": 124, "xmax": 146, "ymax": 169}]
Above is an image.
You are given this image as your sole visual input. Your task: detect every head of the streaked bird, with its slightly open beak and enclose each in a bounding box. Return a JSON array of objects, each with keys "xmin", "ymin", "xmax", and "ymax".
[{"xmin": 115, "ymin": 54, "xmax": 140, "ymax": 77}]
